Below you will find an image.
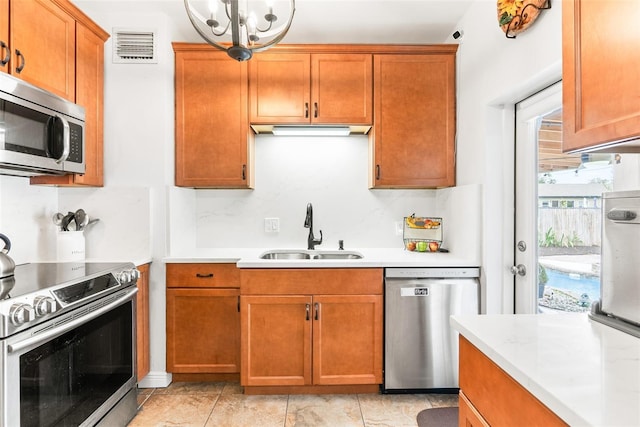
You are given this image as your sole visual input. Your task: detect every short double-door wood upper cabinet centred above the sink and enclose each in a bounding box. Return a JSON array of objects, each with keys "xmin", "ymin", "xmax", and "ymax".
[{"xmin": 249, "ymin": 53, "xmax": 373, "ymax": 125}]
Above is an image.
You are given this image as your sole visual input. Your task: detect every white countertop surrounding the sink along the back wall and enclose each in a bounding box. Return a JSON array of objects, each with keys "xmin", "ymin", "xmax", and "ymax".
[{"xmin": 163, "ymin": 248, "xmax": 479, "ymax": 268}]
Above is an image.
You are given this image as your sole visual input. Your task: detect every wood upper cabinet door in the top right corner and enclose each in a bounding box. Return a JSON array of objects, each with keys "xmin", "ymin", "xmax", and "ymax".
[{"xmin": 562, "ymin": 0, "xmax": 640, "ymax": 152}]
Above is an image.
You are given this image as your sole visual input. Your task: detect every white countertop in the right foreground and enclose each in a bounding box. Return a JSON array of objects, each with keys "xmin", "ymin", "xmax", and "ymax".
[{"xmin": 451, "ymin": 314, "xmax": 640, "ymax": 427}]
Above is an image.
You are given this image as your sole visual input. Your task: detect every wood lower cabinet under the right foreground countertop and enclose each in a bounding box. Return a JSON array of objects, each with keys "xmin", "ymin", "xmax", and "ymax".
[{"xmin": 459, "ymin": 336, "xmax": 567, "ymax": 427}]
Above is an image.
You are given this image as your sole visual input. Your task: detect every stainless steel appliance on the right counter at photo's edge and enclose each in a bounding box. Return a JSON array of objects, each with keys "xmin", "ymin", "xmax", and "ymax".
[{"xmin": 590, "ymin": 191, "xmax": 640, "ymax": 337}]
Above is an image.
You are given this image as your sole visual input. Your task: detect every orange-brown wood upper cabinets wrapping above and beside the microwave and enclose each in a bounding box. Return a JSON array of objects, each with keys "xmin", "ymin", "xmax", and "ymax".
[{"xmin": 18, "ymin": 0, "xmax": 109, "ymax": 187}]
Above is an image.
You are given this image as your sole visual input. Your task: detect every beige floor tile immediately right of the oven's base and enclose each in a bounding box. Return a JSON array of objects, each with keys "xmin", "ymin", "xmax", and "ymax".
[{"xmin": 129, "ymin": 393, "xmax": 218, "ymax": 427}]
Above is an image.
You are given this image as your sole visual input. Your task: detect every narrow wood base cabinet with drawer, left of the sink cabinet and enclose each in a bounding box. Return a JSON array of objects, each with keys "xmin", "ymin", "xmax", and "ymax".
[{"xmin": 167, "ymin": 264, "xmax": 240, "ymax": 380}]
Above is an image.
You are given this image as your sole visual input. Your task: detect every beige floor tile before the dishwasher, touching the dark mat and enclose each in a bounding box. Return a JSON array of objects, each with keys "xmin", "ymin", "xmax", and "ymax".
[{"xmin": 358, "ymin": 394, "xmax": 431, "ymax": 427}]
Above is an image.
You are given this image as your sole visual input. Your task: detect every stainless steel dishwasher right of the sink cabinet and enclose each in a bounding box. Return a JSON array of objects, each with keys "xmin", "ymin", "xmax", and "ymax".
[{"xmin": 382, "ymin": 267, "xmax": 480, "ymax": 393}]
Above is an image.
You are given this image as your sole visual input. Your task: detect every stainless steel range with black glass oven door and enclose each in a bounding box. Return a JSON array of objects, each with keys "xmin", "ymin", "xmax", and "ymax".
[{"xmin": 0, "ymin": 263, "xmax": 139, "ymax": 427}]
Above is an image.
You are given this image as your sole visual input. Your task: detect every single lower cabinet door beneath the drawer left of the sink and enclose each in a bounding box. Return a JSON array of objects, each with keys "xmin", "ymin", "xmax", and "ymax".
[{"xmin": 167, "ymin": 288, "xmax": 240, "ymax": 373}]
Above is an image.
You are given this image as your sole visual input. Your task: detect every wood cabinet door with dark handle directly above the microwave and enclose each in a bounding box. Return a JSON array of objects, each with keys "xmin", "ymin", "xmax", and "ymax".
[{"xmin": 9, "ymin": 0, "xmax": 76, "ymax": 102}]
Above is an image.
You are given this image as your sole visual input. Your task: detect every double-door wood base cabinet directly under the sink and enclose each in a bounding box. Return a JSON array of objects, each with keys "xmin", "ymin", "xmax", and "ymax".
[{"xmin": 241, "ymin": 269, "xmax": 382, "ymax": 391}]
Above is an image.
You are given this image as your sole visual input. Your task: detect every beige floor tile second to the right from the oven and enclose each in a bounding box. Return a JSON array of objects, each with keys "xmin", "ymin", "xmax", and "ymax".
[{"xmin": 206, "ymin": 394, "xmax": 287, "ymax": 427}]
